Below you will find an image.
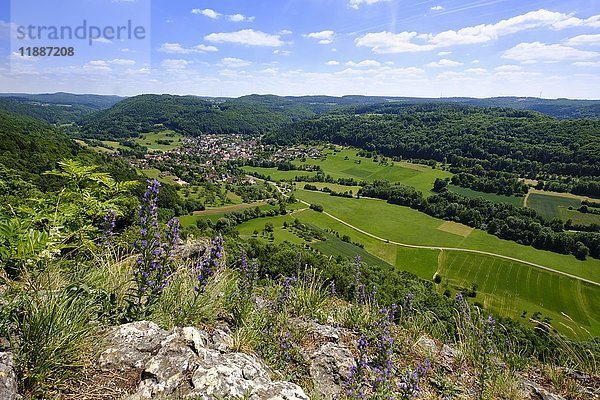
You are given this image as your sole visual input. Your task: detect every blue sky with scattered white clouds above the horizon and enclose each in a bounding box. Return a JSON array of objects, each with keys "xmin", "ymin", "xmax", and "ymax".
[{"xmin": 0, "ymin": 0, "xmax": 600, "ymax": 99}]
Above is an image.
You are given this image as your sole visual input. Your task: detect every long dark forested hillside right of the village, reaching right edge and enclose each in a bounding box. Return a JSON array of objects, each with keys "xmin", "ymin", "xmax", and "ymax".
[{"xmin": 266, "ymin": 104, "xmax": 600, "ymax": 176}]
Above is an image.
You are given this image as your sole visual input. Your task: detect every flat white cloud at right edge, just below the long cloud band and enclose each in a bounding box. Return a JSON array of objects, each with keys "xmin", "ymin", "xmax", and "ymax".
[{"xmin": 502, "ymin": 42, "xmax": 600, "ymax": 61}]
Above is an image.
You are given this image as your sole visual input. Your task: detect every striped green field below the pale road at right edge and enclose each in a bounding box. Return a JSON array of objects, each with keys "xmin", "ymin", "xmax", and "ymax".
[{"xmin": 438, "ymin": 251, "xmax": 600, "ymax": 339}]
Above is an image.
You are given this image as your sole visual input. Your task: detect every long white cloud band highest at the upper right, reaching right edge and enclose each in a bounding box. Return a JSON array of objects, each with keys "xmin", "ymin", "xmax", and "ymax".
[{"xmin": 356, "ymin": 9, "xmax": 600, "ymax": 53}]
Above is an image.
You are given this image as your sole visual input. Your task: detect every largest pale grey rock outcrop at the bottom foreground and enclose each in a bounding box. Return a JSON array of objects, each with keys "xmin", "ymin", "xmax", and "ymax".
[{"xmin": 99, "ymin": 321, "xmax": 308, "ymax": 400}]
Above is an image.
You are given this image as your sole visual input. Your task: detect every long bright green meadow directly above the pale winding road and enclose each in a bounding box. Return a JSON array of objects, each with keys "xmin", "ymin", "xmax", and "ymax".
[{"xmin": 295, "ymin": 190, "xmax": 600, "ymax": 282}]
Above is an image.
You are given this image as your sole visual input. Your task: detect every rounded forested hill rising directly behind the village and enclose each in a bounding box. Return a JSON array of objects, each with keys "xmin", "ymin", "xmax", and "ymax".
[{"xmin": 81, "ymin": 95, "xmax": 315, "ymax": 138}]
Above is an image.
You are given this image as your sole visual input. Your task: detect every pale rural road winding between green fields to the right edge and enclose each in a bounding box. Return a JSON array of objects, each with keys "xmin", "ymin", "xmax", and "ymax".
[{"xmin": 255, "ymin": 177, "xmax": 600, "ymax": 286}]
